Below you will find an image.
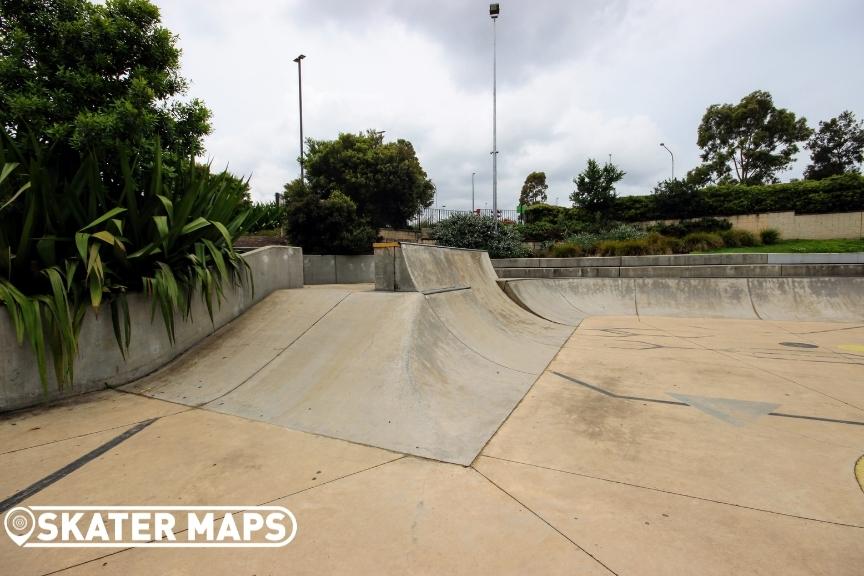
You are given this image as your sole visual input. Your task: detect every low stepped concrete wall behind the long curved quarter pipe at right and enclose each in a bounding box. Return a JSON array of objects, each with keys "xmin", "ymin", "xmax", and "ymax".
[{"xmin": 492, "ymin": 252, "xmax": 864, "ymax": 278}]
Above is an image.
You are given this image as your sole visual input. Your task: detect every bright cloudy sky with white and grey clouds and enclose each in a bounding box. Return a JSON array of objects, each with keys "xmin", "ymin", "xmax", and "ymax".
[{"xmin": 155, "ymin": 0, "xmax": 864, "ymax": 208}]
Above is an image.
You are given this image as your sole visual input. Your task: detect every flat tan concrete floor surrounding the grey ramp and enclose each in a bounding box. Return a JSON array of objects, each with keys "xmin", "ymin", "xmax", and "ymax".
[{"xmin": 0, "ymin": 286, "xmax": 864, "ymax": 575}]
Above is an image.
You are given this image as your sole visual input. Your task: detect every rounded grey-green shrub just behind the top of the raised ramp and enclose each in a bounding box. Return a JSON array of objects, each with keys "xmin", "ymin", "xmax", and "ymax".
[{"xmin": 434, "ymin": 214, "xmax": 530, "ymax": 258}]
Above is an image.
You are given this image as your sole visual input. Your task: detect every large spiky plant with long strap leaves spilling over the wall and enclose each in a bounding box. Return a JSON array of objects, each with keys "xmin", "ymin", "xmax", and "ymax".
[{"xmin": 0, "ymin": 133, "xmax": 258, "ymax": 386}]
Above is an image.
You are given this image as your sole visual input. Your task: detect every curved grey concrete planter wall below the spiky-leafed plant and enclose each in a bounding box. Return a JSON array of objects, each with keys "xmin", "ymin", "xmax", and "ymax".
[{"xmin": 0, "ymin": 246, "xmax": 303, "ymax": 412}]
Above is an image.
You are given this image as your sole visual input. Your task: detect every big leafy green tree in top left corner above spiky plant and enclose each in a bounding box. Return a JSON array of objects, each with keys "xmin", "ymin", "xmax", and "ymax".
[{"xmin": 0, "ymin": 0, "xmax": 210, "ymax": 165}]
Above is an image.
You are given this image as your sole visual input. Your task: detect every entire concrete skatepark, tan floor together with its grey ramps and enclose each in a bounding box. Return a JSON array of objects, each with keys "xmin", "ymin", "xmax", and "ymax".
[{"xmin": 0, "ymin": 243, "xmax": 864, "ymax": 575}]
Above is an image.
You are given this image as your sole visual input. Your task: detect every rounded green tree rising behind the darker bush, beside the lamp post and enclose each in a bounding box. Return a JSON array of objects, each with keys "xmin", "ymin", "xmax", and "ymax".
[{"xmin": 305, "ymin": 130, "xmax": 435, "ymax": 229}]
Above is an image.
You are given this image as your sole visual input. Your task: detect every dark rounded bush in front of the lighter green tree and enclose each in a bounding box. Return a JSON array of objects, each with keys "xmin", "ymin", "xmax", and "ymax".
[{"xmin": 285, "ymin": 179, "xmax": 377, "ymax": 254}]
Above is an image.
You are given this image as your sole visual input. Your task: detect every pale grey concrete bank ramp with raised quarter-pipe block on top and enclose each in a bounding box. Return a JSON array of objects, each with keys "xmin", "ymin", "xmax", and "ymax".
[{"xmin": 127, "ymin": 247, "xmax": 572, "ymax": 465}]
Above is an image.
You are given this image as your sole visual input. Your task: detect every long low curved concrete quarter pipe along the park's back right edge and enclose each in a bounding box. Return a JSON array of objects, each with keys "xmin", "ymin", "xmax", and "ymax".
[{"xmin": 501, "ymin": 277, "xmax": 864, "ymax": 326}]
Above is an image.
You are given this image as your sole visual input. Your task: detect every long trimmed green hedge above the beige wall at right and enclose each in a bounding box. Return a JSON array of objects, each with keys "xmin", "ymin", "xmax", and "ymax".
[{"xmin": 612, "ymin": 174, "xmax": 864, "ymax": 222}]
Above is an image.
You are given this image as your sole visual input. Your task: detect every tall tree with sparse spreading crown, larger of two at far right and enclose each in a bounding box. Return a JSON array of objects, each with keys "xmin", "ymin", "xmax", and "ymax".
[{"xmin": 688, "ymin": 90, "xmax": 812, "ymax": 185}]
